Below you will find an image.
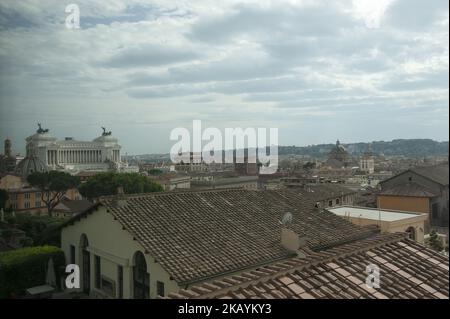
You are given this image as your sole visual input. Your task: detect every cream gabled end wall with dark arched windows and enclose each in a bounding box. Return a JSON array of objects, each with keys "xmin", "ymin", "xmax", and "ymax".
[{"xmin": 61, "ymin": 207, "xmax": 179, "ymax": 299}]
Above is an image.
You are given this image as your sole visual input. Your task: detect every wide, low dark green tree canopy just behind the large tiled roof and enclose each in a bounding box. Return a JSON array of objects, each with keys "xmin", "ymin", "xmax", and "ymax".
[{"xmin": 79, "ymin": 172, "xmax": 163, "ymax": 199}]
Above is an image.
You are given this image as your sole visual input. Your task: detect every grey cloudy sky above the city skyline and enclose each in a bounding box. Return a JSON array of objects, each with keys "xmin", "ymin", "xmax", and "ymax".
[{"xmin": 0, "ymin": 0, "xmax": 449, "ymax": 154}]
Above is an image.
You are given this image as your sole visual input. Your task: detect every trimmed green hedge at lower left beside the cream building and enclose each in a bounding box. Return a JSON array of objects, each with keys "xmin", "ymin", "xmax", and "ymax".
[{"xmin": 0, "ymin": 246, "xmax": 65, "ymax": 298}]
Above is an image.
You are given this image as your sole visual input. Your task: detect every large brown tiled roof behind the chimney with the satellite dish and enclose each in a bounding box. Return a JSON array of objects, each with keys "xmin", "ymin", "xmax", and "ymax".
[{"xmin": 96, "ymin": 190, "xmax": 376, "ymax": 284}]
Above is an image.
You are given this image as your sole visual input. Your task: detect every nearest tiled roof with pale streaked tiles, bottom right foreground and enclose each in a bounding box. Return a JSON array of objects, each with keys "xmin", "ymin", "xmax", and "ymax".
[{"xmin": 169, "ymin": 234, "xmax": 449, "ymax": 299}]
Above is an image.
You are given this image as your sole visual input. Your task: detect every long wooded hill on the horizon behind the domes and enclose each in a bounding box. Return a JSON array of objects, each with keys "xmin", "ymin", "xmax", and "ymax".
[{"xmin": 278, "ymin": 139, "xmax": 448, "ymax": 158}]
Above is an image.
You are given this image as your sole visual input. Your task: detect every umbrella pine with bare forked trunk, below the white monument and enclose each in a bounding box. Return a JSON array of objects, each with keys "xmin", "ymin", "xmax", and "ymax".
[{"xmin": 27, "ymin": 171, "xmax": 80, "ymax": 217}]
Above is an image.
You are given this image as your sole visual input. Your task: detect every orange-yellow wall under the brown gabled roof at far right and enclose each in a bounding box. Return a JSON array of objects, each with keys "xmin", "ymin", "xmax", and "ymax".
[{"xmin": 377, "ymin": 195, "xmax": 430, "ymax": 214}]
